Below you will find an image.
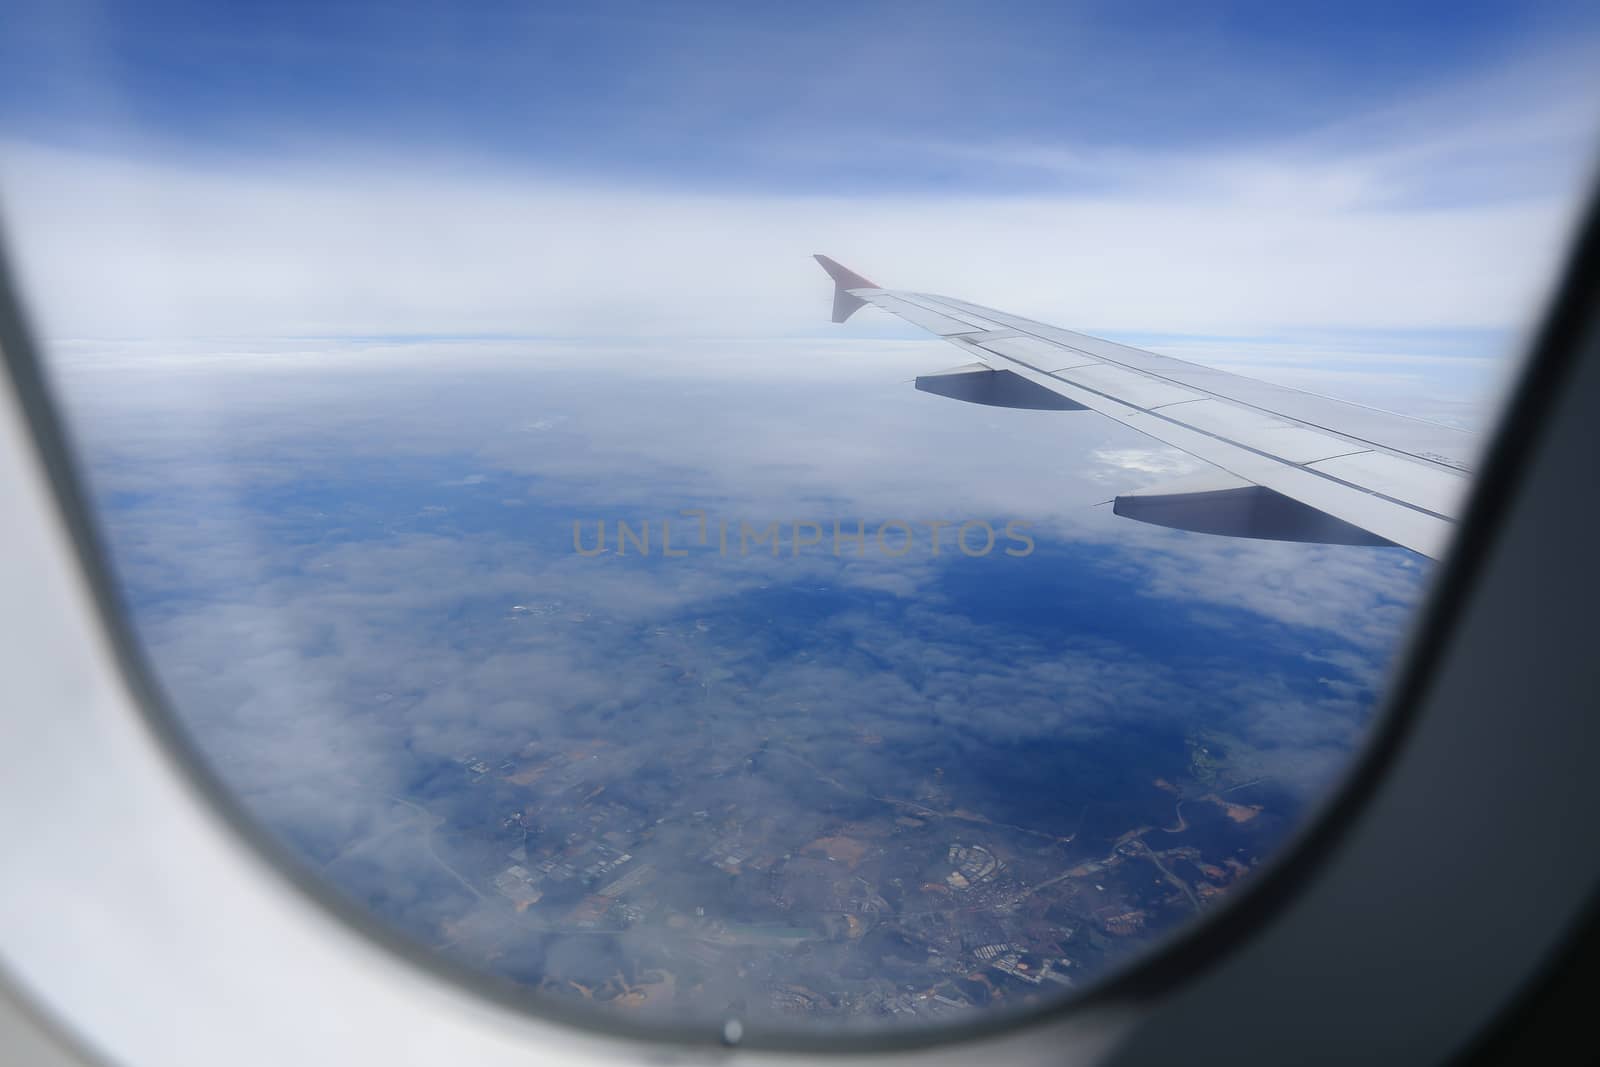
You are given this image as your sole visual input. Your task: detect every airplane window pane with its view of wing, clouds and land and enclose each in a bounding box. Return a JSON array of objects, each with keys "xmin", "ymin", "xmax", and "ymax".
[{"xmin": 0, "ymin": 3, "xmax": 1600, "ymax": 1043}]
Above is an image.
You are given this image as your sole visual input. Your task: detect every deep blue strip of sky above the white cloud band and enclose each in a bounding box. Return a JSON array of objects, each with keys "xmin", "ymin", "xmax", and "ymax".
[{"xmin": 0, "ymin": 3, "xmax": 1600, "ymax": 192}]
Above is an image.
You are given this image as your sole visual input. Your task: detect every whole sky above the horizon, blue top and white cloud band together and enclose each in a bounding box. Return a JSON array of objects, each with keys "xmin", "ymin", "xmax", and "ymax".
[{"xmin": 0, "ymin": 3, "xmax": 1600, "ymax": 416}]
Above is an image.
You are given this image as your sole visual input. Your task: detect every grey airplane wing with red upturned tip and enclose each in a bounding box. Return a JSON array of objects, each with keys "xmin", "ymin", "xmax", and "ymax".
[{"xmin": 816, "ymin": 256, "xmax": 1477, "ymax": 558}]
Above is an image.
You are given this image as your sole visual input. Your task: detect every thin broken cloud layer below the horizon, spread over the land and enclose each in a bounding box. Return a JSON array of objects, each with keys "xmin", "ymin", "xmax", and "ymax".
[{"xmin": 46, "ymin": 341, "xmax": 1422, "ymax": 1036}]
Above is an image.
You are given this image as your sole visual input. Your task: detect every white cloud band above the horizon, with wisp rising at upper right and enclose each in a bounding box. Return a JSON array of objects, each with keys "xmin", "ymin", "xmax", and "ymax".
[{"xmin": 0, "ymin": 28, "xmax": 1597, "ymax": 347}]
